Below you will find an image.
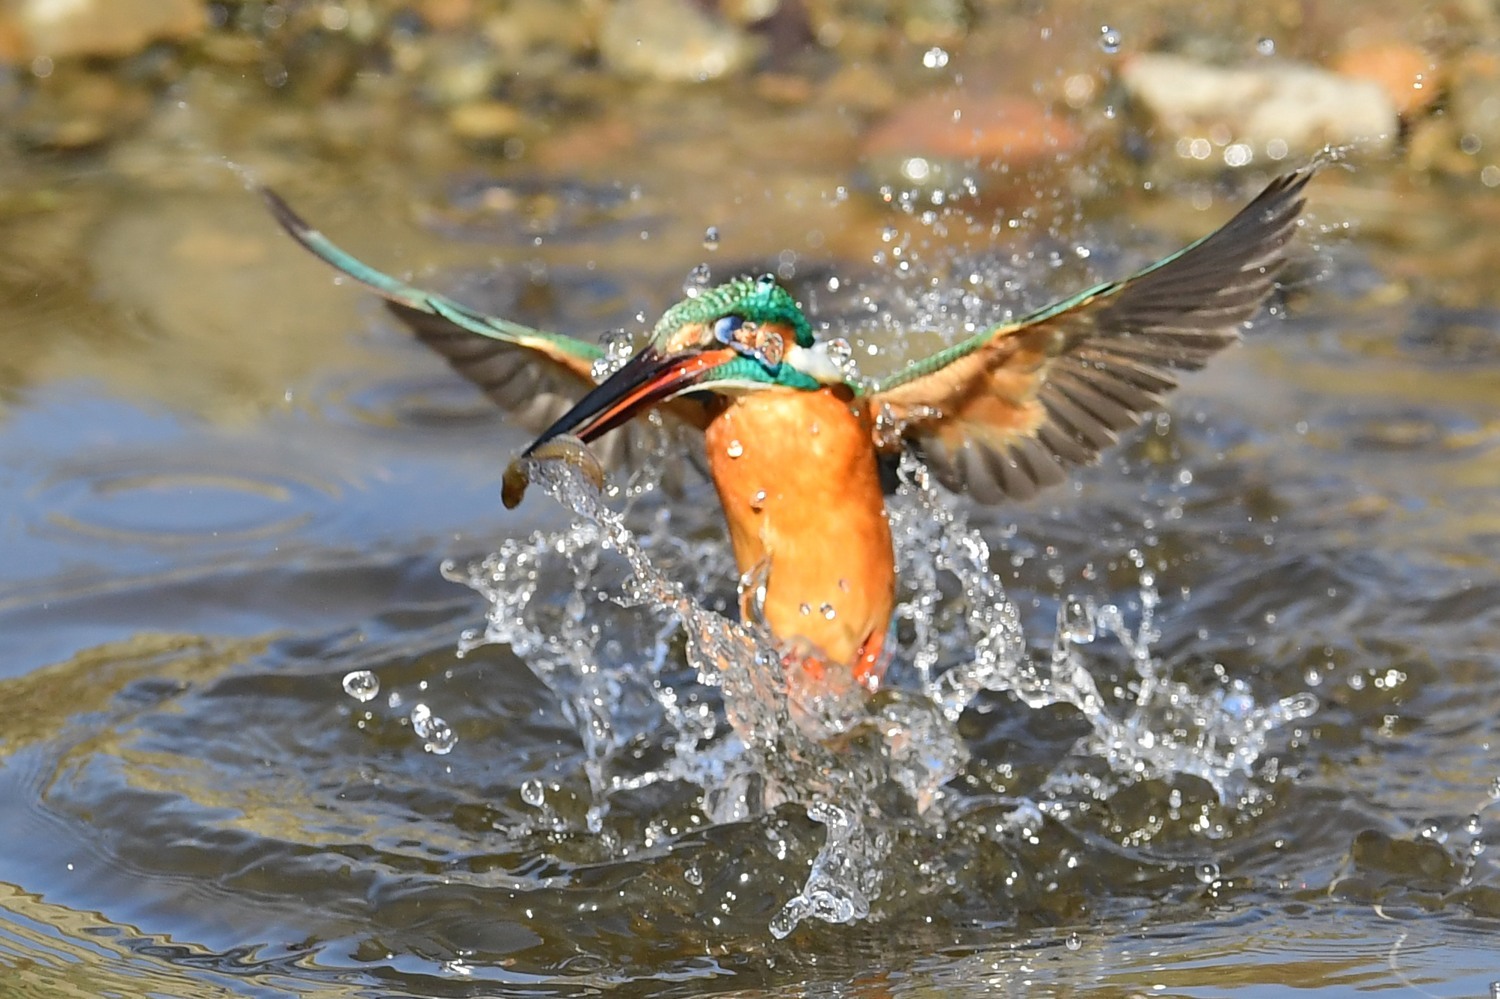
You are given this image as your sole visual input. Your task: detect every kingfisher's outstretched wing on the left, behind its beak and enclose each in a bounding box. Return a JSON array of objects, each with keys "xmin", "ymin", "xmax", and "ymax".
[{"xmin": 261, "ymin": 188, "xmax": 708, "ymax": 492}]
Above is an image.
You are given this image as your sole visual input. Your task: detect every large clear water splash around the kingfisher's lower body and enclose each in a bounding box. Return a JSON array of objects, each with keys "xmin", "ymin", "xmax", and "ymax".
[{"xmin": 446, "ymin": 450, "xmax": 1316, "ymax": 936}]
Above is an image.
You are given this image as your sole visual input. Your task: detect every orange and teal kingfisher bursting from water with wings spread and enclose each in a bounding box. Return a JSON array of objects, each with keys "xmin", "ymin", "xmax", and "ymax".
[{"xmin": 263, "ymin": 164, "xmax": 1319, "ymax": 692}]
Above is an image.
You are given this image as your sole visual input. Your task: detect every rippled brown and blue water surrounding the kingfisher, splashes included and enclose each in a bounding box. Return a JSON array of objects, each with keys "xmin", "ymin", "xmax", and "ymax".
[{"xmin": 0, "ymin": 66, "xmax": 1500, "ymax": 996}]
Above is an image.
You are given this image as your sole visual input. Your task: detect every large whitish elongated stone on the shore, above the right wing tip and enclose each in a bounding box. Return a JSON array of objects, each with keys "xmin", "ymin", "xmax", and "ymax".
[{"xmin": 1121, "ymin": 54, "xmax": 1400, "ymax": 167}]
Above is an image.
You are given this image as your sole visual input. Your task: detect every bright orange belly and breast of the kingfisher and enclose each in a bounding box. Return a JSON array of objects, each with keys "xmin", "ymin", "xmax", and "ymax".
[{"xmin": 707, "ymin": 382, "xmax": 896, "ymax": 687}]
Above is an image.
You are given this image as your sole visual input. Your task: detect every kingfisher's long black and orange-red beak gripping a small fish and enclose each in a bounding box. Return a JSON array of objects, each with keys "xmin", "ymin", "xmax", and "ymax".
[{"xmin": 521, "ymin": 340, "xmax": 735, "ymax": 458}]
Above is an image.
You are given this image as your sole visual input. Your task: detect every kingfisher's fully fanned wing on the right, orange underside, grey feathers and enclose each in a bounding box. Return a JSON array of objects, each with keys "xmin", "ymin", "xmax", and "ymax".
[{"xmin": 867, "ymin": 164, "xmax": 1320, "ymax": 503}]
